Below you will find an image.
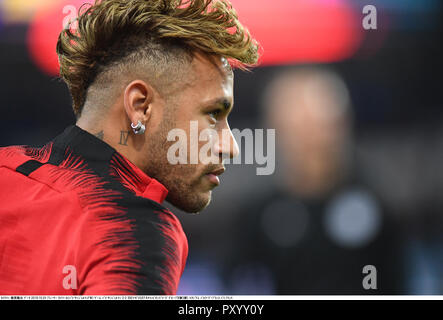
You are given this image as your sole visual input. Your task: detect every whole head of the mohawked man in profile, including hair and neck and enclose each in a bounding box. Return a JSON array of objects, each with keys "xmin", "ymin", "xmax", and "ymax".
[{"xmin": 57, "ymin": 0, "xmax": 258, "ymax": 212}]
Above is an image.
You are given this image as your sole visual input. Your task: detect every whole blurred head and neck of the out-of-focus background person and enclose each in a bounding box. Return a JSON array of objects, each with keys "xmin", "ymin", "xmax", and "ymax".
[{"xmin": 264, "ymin": 65, "xmax": 352, "ymax": 196}]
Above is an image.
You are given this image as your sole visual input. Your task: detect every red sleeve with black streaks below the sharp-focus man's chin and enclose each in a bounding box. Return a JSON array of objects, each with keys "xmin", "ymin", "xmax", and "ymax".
[{"xmin": 77, "ymin": 195, "xmax": 188, "ymax": 295}]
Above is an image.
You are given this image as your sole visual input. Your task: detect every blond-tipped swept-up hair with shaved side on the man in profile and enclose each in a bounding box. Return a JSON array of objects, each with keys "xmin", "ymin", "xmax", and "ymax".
[{"xmin": 57, "ymin": 0, "xmax": 259, "ymax": 117}]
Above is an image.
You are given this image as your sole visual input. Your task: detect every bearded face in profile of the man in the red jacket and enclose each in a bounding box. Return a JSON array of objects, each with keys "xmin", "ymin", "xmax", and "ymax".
[{"xmin": 142, "ymin": 54, "xmax": 238, "ymax": 213}]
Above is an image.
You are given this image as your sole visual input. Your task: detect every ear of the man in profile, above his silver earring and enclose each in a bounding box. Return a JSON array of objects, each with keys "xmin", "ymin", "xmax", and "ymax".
[{"xmin": 124, "ymin": 80, "xmax": 154, "ymax": 125}]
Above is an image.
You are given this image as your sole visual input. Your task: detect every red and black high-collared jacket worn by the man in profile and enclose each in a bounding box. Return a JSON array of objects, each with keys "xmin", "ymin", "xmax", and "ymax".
[{"xmin": 0, "ymin": 126, "xmax": 188, "ymax": 295}]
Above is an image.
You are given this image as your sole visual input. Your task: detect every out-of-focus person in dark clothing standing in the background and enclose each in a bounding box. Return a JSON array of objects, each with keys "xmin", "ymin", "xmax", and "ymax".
[{"xmin": 225, "ymin": 66, "xmax": 402, "ymax": 294}]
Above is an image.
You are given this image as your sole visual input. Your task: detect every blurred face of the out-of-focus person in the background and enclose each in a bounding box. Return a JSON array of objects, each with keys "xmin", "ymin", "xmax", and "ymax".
[{"xmin": 269, "ymin": 74, "xmax": 348, "ymax": 169}]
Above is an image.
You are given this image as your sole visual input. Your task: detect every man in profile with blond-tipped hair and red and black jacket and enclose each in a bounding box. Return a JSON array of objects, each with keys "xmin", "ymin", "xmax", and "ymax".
[{"xmin": 0, "ymin": 0, "xmax": 258, "ymax": 295}]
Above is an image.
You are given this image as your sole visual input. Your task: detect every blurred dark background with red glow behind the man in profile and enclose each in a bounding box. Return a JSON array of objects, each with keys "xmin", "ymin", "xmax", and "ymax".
[{"xmin": 0, "ymin": 0, "xmax": 443, "ymax": 295}]
